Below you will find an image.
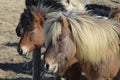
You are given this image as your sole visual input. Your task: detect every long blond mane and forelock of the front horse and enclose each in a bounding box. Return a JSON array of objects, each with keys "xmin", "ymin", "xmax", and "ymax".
[{"xmin": 44, "ymin": 12, "xmax": 120, "ymax": 64}]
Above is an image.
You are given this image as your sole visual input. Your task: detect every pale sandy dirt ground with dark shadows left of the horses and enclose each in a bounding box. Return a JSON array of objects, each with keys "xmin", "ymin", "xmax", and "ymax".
[{"xmin": 0, "ymin": 0, "xmax": 119, "ymax": 80}]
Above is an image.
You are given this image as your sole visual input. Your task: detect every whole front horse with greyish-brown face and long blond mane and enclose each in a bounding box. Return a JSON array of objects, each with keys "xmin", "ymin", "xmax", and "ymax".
[{"xmin": 44, "ymin": 12, "xmax": 120, "ymax": 80}]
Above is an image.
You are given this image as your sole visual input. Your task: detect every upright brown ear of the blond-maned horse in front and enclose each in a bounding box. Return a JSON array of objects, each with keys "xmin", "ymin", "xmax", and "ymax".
[{"xmin": 60, "ymin": 15, "xmax": 70, "ymax": 32}]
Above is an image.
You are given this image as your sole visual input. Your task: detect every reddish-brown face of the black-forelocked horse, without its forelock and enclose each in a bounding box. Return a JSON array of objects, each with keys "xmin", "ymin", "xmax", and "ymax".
[{"xmin": 19, "ymin": 12, "xmax": 44, "ymax": 52}]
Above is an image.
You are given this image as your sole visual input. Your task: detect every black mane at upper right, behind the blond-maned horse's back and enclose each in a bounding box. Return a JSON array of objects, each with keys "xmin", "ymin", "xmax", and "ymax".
[{"xmin": 85, "ymin": 4, "xmax": 111, "ymax": 17}]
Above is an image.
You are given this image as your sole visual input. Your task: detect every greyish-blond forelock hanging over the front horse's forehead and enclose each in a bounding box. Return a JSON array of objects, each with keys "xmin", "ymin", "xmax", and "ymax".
[{"xmin": 43, "ymin": 12, "xmax": 62, "ymax": 47}]
